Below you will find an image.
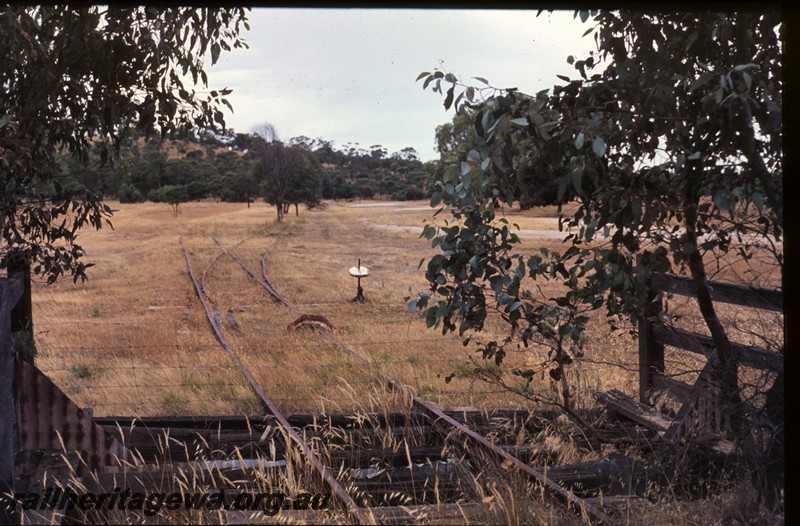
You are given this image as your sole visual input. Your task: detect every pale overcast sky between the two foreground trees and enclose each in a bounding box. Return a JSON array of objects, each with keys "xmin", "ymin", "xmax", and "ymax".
[{"xmin": 203, "ymin": 8, "xmax": 594, "ymax": 160}]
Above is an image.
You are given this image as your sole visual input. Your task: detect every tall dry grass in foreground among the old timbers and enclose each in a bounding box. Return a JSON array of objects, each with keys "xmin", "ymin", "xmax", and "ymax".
[{"xmin": 32, "ymin": 384, "xmax": 780, "ymax": 526}]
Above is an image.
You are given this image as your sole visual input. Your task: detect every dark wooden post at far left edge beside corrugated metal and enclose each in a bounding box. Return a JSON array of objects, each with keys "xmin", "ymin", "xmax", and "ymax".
[{"xmin": 0, "ymin": 274, "xmax": 23, "ymax": 524}]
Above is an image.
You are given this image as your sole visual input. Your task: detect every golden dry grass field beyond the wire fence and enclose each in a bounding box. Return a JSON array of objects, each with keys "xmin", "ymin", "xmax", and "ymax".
[{"xmin": 34, "ymin": 201, "xmax": 775, "ymax": 415}]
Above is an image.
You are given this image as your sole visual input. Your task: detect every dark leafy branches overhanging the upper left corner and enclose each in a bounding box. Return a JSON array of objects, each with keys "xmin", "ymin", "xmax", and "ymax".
[{"xmin": 0, "ymin": 5, "xmax": 247, "ymax": 282}]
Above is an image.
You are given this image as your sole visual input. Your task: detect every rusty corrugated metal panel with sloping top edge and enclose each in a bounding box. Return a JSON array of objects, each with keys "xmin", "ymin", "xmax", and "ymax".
[{"xmin": 16, "ymin": 360, "xmax": 129, "ymax": 469}]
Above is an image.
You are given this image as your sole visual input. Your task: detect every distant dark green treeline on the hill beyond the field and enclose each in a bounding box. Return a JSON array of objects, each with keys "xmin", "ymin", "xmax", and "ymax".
[{"xmin": 55, "ymin": 131, "xmax": 434, "ymax": 215}]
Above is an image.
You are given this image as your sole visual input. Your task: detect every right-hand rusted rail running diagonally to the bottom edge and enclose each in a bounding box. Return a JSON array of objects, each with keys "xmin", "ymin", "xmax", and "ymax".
[{"xmin": 212, "ymin": 236, "xmax": 612, "ymax": 524}]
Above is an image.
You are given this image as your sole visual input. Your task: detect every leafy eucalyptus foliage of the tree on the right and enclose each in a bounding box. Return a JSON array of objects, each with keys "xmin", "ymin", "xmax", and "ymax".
[{"xmin": 409, "ymin": 11, "xmax": 783, "ymax": 410}]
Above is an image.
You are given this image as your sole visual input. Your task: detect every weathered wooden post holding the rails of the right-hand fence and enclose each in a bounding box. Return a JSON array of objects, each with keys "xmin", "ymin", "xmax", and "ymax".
[{"xmin": 636, "ymin": 254, "xmax": 664, "ymax": 404}]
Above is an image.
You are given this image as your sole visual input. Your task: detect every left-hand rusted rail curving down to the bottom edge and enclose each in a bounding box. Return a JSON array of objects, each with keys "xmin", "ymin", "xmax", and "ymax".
[{"xmin": 180, "ymin": 236, "xmax": 368, "ymax": 523}]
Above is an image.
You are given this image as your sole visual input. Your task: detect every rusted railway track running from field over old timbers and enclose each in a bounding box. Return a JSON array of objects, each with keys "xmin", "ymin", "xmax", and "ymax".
[{"xmin": 173, "ymin": 235, "xmax": 611, "ymax": 524}]
